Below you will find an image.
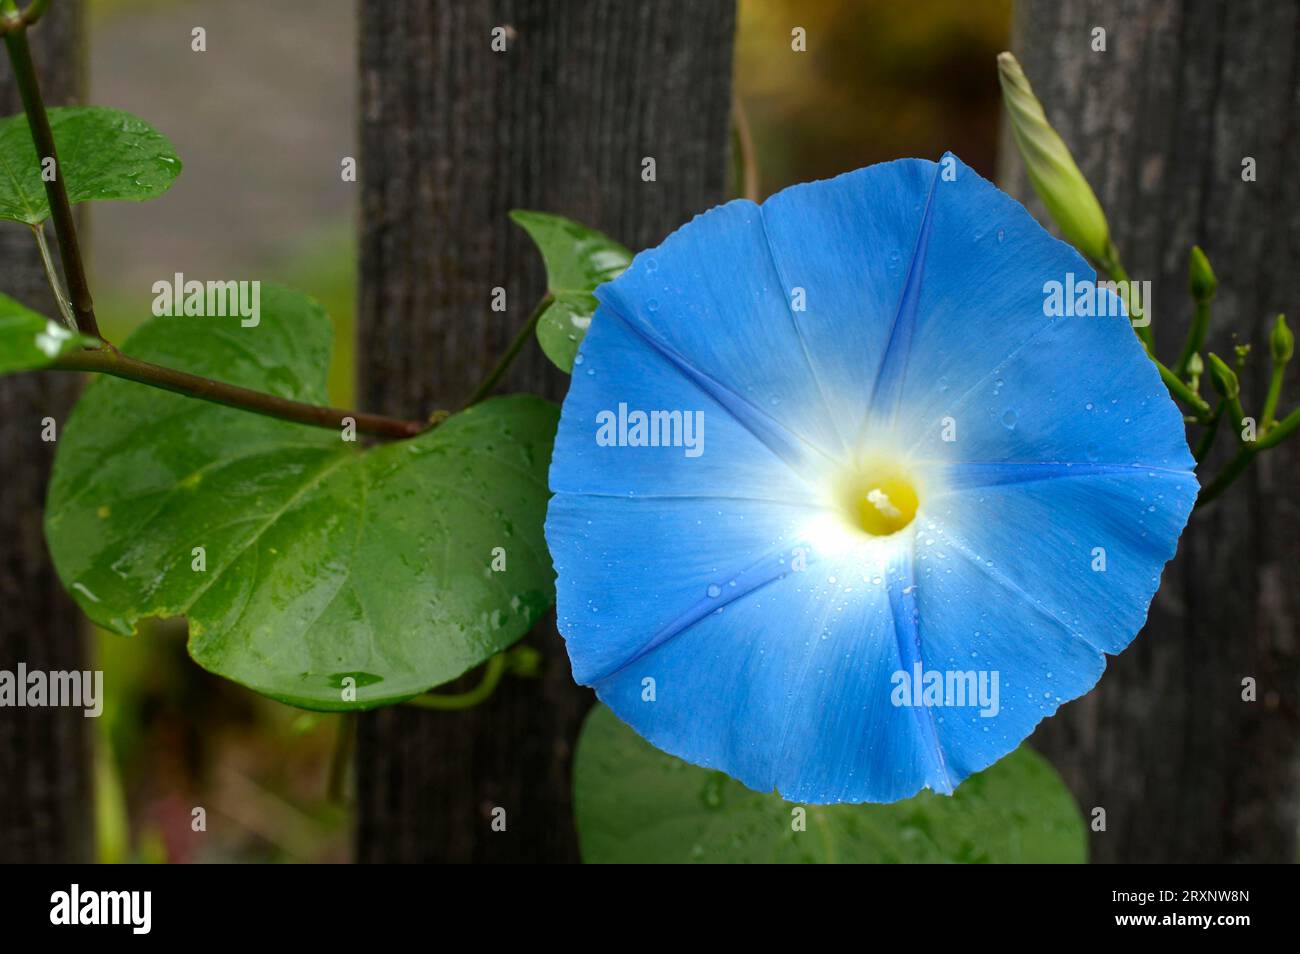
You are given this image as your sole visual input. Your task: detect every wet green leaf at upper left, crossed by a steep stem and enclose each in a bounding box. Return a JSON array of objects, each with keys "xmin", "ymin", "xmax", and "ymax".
[{"xmin": 0, "ymin": 107, "xmax": 181, "ymax": 225}]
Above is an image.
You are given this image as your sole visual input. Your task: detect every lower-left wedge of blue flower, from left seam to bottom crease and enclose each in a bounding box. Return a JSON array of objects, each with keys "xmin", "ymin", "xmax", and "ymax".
[{"xmin": 547, "ymin": 495, "xmax": 926, "ymax": 803}]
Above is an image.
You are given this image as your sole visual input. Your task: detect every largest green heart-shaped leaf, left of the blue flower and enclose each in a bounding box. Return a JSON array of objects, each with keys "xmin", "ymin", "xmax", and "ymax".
[{"xmin": 46, "ymin": 285, "xmax": 558, "ymax": 710}]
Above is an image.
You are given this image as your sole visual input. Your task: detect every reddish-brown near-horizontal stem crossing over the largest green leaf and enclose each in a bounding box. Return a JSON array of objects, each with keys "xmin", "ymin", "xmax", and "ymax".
[{"xmin": 51, "ymin": 348, "xmax": 432, "ymax": 438}]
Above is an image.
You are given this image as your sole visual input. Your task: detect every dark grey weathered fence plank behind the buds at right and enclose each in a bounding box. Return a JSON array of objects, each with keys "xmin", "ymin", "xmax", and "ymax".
[{"xmin": 989, "ymin": 0, "xmax": 1300, "ymax": 862}]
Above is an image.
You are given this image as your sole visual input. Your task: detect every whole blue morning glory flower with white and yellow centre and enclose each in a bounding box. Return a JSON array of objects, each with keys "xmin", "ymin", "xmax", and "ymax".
[{"xmin": 546, "ymin": 156, "xmax": 1197, "ymax": 802}]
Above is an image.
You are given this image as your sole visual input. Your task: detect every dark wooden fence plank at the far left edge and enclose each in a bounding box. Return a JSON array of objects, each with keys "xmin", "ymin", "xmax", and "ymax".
[{"xmin": 0, "ymin": 0, "xmax": 92, "ymax": 863}]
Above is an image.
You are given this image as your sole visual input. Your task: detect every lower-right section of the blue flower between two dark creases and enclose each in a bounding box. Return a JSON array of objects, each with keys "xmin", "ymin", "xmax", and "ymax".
[{"xmin": 917, "ymin": 469, "xmax": 1197, "ymax": 779}]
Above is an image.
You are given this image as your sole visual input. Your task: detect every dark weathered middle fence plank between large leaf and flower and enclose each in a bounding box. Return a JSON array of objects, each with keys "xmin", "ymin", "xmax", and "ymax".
[{"xmin": 356, "ymin": 0, "xmax": 735, "ymax": 862}]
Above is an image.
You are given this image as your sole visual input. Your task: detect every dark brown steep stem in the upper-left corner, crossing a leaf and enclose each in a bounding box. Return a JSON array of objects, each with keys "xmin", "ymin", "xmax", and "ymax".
[{"xmin": 4, "ymin": 13, "xmax": 103, "ymax": 338}]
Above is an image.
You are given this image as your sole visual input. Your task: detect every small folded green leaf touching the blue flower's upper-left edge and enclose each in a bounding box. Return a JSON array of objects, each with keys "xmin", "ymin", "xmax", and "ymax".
[{"xmin": 510, "ymin": 209, "xmax": 632, "ymax": 373}]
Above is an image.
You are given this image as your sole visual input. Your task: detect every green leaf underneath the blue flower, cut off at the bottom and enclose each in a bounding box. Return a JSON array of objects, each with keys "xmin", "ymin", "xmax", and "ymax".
[{"xmin": 573, "ymin": 703, "xmax": 1087, "ymax": 863}]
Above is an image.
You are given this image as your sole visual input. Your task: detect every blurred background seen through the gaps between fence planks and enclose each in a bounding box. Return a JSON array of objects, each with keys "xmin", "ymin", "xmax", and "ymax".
[{"xmin": 81, "ymin": 0, "xmax": 1010, "ymax": 862}]
